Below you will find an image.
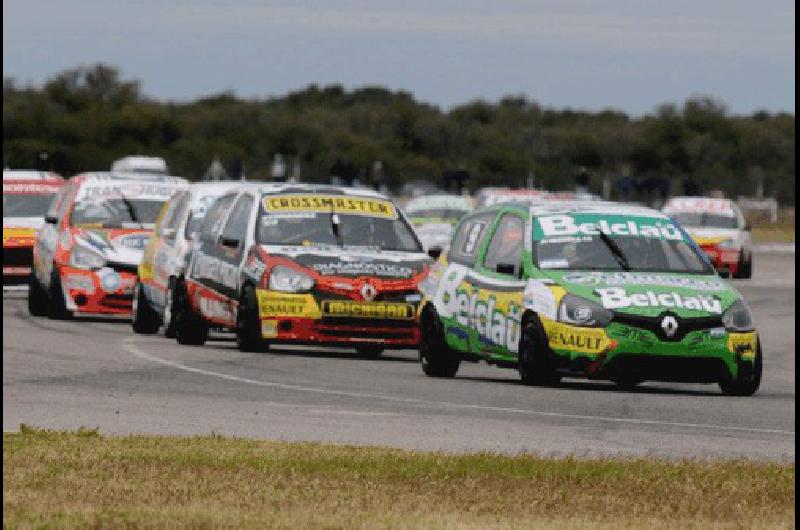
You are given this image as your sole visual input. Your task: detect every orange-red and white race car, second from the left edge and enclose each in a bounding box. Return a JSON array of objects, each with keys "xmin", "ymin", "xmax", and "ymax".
[{"xmin": 28, "ymin": 173, "xmax": 187, "ymax": 318}]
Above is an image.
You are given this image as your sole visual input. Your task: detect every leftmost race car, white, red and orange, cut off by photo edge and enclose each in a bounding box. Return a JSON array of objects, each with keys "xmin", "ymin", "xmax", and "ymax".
[{"xmin": 3, "ymin": 170, "xmax": 64, "ymax": 289}]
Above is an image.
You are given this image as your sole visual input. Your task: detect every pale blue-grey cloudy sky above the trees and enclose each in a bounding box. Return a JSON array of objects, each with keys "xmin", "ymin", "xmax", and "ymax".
[{"xmin": 3, "ymin": 0, "xmax": 795, "ymax": 115}]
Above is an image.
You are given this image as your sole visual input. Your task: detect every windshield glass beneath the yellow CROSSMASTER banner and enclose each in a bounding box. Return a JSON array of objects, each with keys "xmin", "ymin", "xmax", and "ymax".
[{"xmin": 256, "ymin": 195, "xmax": 422, "ymax": 252}]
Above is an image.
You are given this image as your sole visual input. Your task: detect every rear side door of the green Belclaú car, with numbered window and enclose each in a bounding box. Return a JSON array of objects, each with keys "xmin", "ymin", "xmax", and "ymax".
[{"xmin": 433, "ymin": 211, "xmax": 497, "ymax": 353}]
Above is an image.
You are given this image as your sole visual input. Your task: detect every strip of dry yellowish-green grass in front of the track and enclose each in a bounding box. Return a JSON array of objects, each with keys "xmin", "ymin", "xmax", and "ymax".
[{"xmin": 3, "ymin": 427, "xmax": 794, "ymax": 528}]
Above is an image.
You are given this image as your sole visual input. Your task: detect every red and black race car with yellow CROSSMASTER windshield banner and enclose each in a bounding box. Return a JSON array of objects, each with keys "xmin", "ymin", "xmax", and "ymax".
[{"xmin": 173, "ymin": 184, "xmax": 431, "ymax": 357}]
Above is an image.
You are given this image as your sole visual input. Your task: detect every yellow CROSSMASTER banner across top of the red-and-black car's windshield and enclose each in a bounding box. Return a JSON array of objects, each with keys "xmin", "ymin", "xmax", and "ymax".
[{"xmin": 263, "ymin": 194, "xmax": 397, "ymax": 219}]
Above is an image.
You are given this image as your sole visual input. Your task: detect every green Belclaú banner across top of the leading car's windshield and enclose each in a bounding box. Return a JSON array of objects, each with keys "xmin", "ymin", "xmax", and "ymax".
[{"xmin": 533, "ymin": 214, "xmax": 683, "ymax": 241}]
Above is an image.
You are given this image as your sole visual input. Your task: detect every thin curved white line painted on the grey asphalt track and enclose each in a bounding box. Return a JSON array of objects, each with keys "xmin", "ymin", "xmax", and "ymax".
[{"xmin": 122, "ymin": 337, "xmax": 795, "ymax": 436}]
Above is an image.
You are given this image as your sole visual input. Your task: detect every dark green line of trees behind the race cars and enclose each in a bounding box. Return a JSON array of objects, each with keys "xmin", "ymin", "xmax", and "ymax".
[{"xmin": 3, "ymin": 64, "xmax": 795, "ymax": 205}]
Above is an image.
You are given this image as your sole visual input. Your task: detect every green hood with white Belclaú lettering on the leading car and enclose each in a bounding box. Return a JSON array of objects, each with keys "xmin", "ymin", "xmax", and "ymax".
[{"xmin": 545, "ymin": 271, "xmax": 740, "ymax": 317}]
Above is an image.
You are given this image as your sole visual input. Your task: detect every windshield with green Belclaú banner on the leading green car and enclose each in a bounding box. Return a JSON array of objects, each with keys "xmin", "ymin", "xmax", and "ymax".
[{"xmin": 533, "ymin": 214, "xmax": 713, "ymax": 274}]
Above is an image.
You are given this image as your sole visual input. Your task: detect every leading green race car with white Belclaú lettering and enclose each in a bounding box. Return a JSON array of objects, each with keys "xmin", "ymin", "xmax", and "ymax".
[{"xmin": 419, "ymin": 201, "xmax": 762, "ymax": 395}]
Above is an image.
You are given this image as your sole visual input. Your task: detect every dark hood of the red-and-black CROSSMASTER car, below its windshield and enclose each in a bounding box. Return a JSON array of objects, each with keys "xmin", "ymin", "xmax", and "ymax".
[{"xmin": 262, "ymin": 245, "xmax": 430, "ymax": 279}]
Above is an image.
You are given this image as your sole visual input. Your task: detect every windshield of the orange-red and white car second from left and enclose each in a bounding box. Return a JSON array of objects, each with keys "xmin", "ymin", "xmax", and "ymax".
[{"xmin": 70, "ymin": 197, "xmax": 164, "ymax": 228}]
